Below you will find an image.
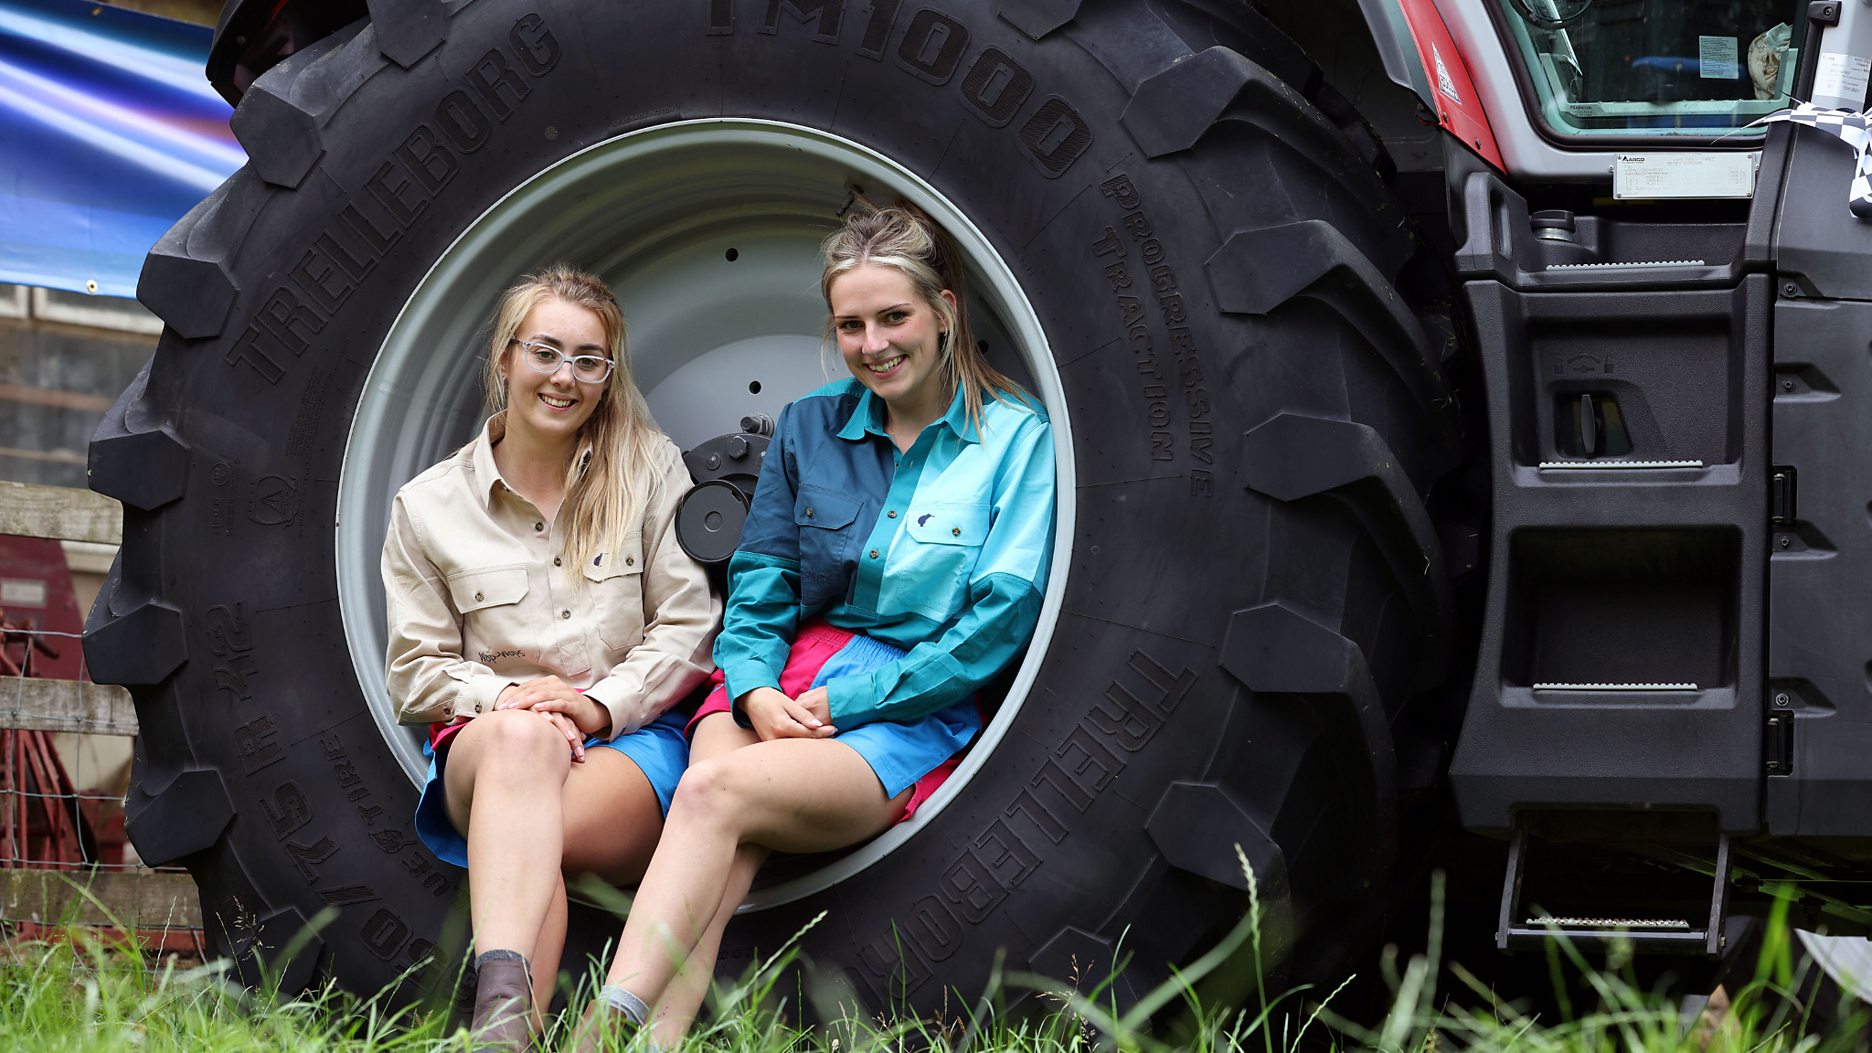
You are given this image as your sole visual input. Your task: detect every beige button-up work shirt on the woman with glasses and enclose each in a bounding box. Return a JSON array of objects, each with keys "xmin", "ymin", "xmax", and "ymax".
[{"xmin": 384, "ymin": 414, "xmax": 721, "ymax": 738}]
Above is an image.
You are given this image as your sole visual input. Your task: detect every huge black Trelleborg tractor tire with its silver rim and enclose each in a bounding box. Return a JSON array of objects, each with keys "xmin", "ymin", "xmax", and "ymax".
[{"xmin": 86, "ymin": 0, "xmax": 1462, "ymax": 1006}]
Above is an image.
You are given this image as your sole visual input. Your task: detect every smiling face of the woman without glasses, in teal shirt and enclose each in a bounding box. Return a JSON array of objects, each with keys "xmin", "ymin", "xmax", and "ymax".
[{"xmin": 827, "ymin": 264, "xmax": 955, "ymax": 427}]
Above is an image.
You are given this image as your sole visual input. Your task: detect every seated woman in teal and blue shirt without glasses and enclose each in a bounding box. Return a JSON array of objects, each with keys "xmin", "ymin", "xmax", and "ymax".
[{"xmin": 578, "ymin": 208, "xmax": 1054, "ymax": 1049}]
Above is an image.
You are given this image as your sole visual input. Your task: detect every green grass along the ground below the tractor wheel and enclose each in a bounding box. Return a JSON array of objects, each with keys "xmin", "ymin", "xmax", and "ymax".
[{"xmin": 0, "ymin": 861, "xmax": 1872, "ymax": 1053}]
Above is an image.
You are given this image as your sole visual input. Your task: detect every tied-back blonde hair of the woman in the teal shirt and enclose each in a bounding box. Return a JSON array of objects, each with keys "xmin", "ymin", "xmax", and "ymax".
[{"xmin": 820, "ymin": 203, "xmax": 1031, "ymax": 433}]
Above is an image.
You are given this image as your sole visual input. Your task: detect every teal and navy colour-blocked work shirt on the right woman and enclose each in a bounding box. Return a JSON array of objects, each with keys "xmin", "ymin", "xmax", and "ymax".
[{"xmin": 715, "ymin": 380, "xmax": 1054, "ymax": 729}]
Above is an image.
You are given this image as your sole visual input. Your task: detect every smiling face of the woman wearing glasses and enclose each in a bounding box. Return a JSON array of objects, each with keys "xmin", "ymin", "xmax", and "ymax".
[{"xmin": 500, "ymin": 296, "xmax": 610, "ymax": 446}]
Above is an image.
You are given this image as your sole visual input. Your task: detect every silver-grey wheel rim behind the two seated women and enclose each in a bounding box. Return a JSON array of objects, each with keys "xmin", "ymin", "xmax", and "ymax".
[{"xmin": 335, "ymin": 120, "xmax": 1075, "ymax": 911}]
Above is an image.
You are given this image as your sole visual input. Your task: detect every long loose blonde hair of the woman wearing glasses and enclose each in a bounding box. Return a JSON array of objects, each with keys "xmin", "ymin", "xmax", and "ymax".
[{"xmin": 483, "ymin": 262, "xmax": 666, "ymax": 568}]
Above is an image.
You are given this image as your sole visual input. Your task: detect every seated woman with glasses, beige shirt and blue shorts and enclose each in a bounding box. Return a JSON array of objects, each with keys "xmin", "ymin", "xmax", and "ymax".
[{"xmin": 384, "ymin": 264, "xmax": 721, "ymax": 1049}]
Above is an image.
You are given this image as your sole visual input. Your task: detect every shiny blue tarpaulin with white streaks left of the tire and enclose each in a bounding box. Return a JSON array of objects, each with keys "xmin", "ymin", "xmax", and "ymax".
[{"xmin": 0, "ymin": 0, "xmax": 247, "ymax": 296}]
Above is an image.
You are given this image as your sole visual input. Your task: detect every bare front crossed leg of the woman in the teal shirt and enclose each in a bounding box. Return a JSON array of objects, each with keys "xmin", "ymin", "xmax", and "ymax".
[{"xmin": 607, "ymin": 738, "xmax": 910, "ymax": 1046}]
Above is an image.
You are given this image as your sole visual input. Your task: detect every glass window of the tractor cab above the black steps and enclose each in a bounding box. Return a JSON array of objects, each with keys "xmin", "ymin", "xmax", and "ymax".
[{"xmin": 1496, "ymin": 0, "xmax": 1806, "ymax": 139}]
